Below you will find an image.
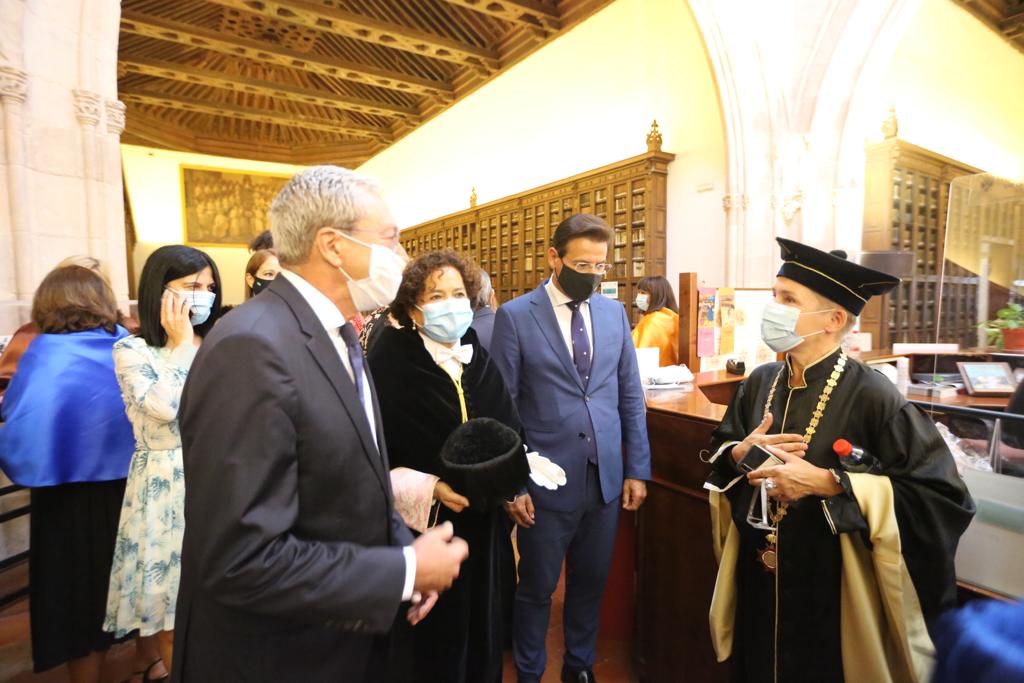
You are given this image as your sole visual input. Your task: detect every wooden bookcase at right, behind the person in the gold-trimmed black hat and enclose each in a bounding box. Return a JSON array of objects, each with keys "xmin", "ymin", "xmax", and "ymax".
[{"xmin": 860, "ymin": 137, "xmax": 979, "ymax": 348}]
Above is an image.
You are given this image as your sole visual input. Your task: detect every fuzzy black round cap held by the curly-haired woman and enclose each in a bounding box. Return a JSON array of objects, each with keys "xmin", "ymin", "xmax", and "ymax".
[{"xmin": 439, "ymin": 418, "xmax": 529, "ymax": 509}]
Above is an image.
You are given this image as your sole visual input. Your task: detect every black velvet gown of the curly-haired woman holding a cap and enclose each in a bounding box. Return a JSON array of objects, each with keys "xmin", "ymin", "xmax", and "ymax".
[{"xmin": 369, "ymin": 327, "xmax": 521, "ymax": 683}]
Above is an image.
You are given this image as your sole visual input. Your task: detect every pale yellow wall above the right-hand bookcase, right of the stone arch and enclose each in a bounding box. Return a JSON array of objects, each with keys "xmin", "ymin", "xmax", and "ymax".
[{"xmin": 865, "ymin": 0, "xmax": 1024, "ymax": 178}]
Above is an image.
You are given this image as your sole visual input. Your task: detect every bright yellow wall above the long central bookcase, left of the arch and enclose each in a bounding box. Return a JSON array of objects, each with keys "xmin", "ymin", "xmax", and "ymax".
[{"xmin": 360, "ymin": 0, "xmax": 726, "ymax": 284}]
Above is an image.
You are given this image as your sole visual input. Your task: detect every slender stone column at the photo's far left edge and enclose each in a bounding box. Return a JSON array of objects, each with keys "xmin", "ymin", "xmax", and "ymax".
[{"xmin": 0, "ymin": 67, "xmax": 35, "ymax": 309}]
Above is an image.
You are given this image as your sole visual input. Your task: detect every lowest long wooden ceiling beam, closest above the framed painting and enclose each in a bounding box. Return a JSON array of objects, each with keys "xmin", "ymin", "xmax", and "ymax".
[{"xmin": 118, "ymin": 89, "xmax": 391, "ymax": 142}]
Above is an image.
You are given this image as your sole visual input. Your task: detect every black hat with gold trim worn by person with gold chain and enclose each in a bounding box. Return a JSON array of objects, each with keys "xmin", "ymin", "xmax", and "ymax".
[{"xmin": 776, "ymin": 238, "xmax": 900, "ymax": 315}]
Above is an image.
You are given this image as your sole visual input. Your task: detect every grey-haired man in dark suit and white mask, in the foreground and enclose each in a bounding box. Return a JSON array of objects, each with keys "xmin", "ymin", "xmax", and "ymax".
[{"xmin": 172, "ymin": 166, "xmax": 467, "ymax": 683}]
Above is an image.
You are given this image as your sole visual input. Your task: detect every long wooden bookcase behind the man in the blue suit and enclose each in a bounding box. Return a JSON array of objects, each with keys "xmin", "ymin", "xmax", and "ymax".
[{"xmin": 401, "ymin": 138, "xmax": 675, "ymax": 324}]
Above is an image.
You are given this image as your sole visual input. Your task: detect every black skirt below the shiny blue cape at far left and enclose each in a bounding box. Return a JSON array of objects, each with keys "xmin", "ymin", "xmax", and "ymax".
[{"xmin": 29, "ymin": 479, "xmax": 125, "ymax": 673}]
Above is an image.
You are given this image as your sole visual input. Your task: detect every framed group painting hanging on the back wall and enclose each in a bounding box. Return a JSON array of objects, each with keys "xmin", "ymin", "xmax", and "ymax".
[{"xmin": 181, "ymin": 164, "xmax": 291, "ymax": 247}]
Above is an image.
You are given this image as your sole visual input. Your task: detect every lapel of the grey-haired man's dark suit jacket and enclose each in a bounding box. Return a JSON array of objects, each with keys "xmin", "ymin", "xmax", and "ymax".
[{"xmin": 267, "ymin": 278, "xmax": 387, "ymax": 490}]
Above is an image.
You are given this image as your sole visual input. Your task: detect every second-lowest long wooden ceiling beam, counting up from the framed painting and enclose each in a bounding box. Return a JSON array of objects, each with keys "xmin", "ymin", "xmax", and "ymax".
[{"xmin": 118, "ymin": 56, "xmax": 419, "ymax": 122}]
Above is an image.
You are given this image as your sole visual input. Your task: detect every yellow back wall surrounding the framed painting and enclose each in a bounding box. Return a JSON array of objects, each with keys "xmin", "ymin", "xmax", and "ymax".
[{"xmin": 121, "ymin": 144, "xmax": 303, "ymax": 304}]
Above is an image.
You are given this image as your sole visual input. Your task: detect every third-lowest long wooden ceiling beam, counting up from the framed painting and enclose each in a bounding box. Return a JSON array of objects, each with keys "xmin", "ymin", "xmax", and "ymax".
[{"xmin": 121, "ymin": 11, "xmax": 453, "ymax": 99}]
